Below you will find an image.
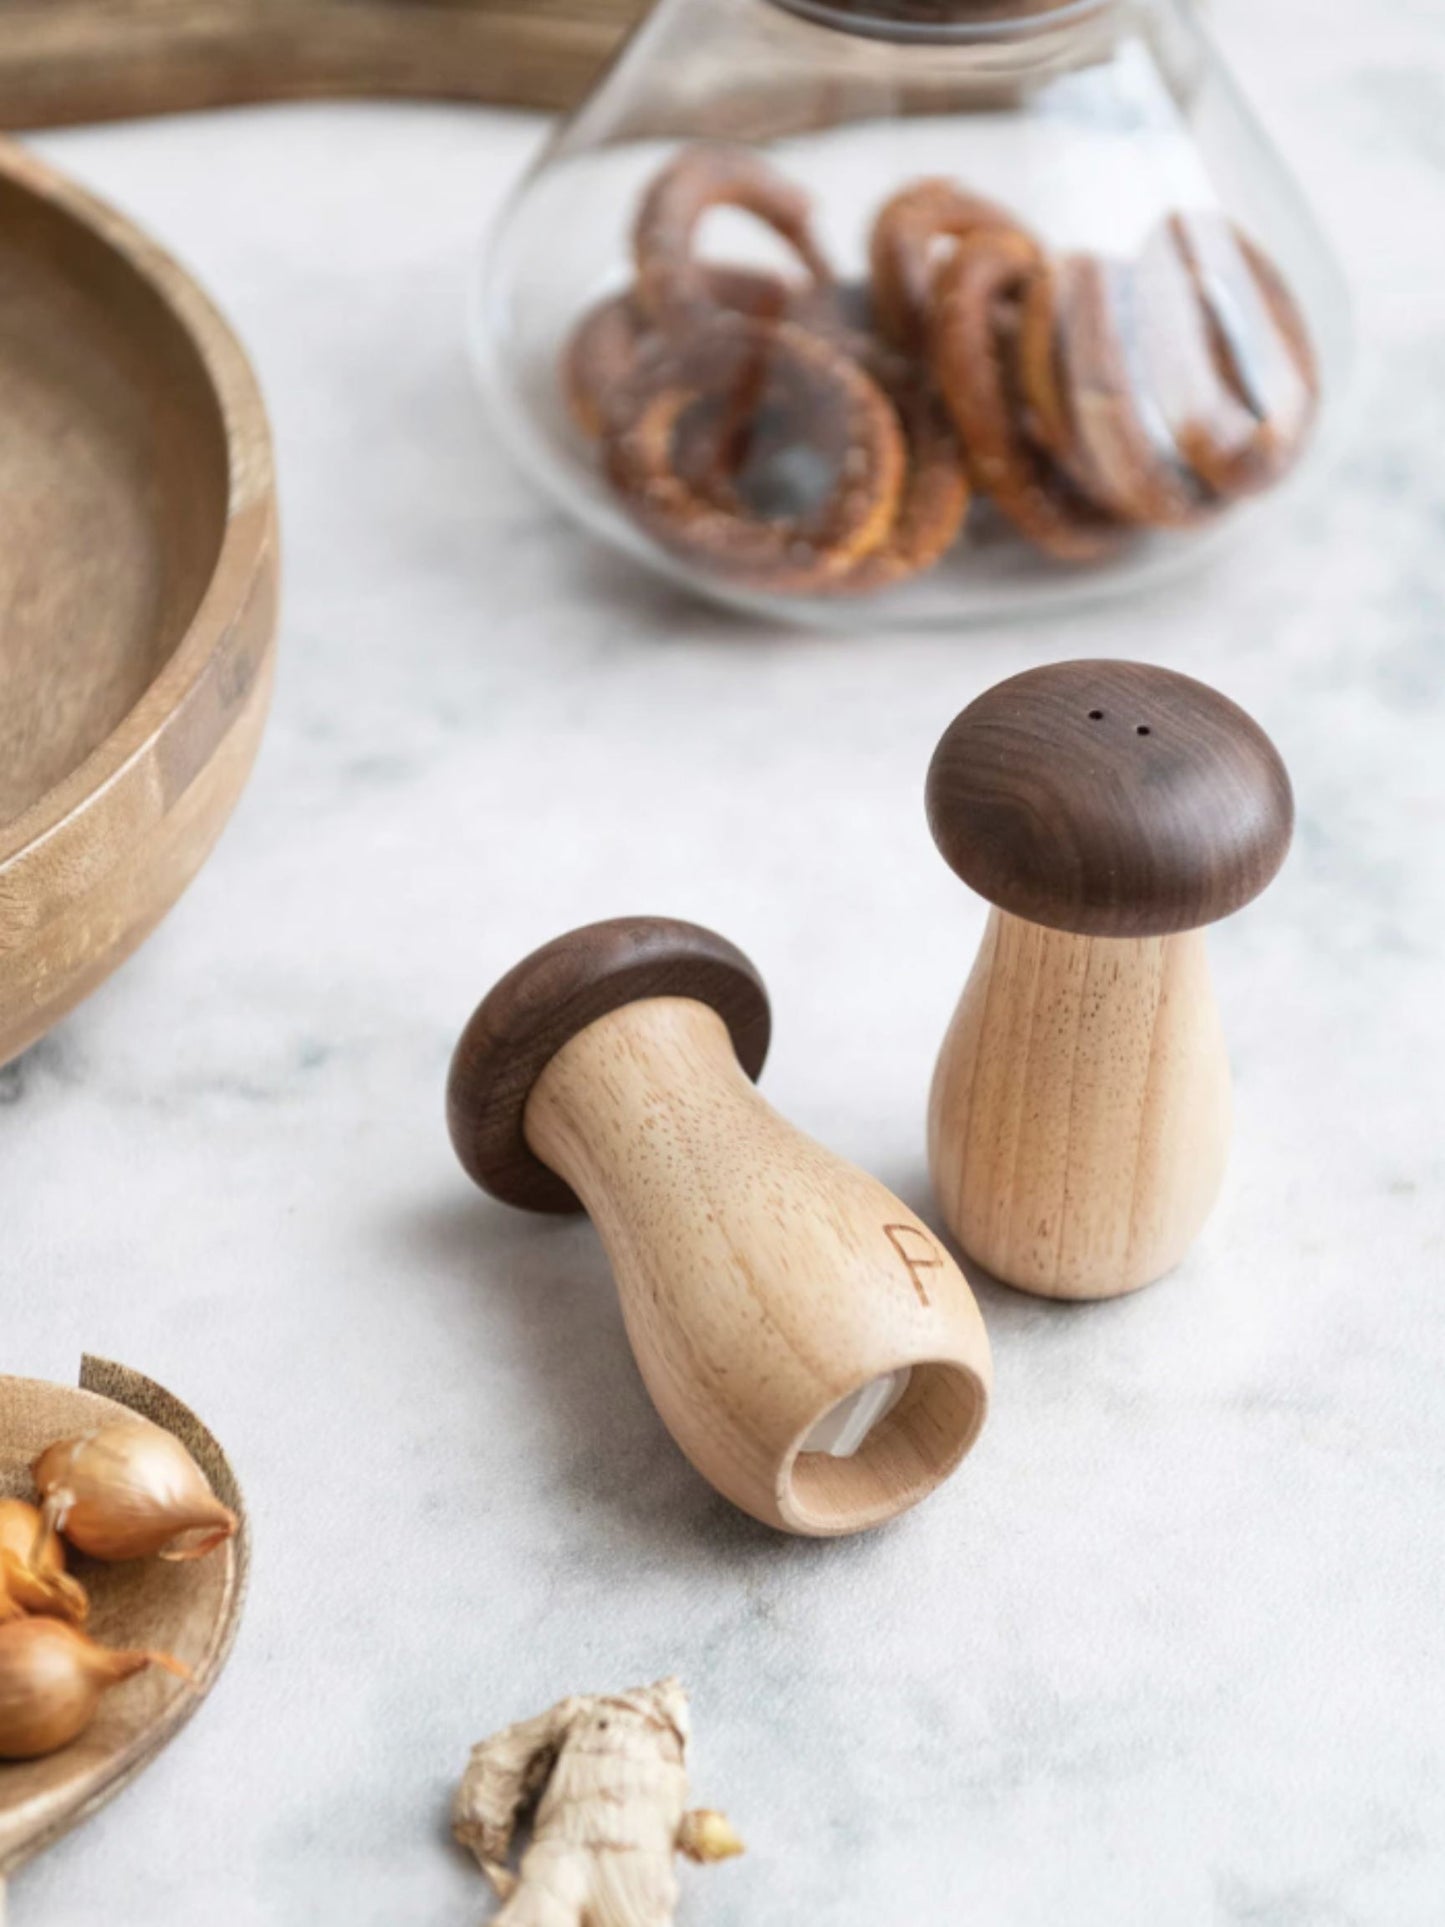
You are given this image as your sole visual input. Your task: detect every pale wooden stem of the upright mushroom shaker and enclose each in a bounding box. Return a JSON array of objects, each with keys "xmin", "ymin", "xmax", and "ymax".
[{"xmin": 929, "ymin": 910, "xmax": 1229, "ymax": 1299}]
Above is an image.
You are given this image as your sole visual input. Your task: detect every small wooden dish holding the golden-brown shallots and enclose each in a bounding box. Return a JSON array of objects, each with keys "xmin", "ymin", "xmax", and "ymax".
[{"xmin": 0, "ymin": 1357, "xmax": 250, "ymax": 1894}]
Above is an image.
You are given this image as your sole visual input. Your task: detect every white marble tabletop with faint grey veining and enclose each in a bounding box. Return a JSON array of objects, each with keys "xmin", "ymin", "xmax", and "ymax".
[{"xmin": 11, "ymin": 0, "xmax": 1445, "ymax": 1927}]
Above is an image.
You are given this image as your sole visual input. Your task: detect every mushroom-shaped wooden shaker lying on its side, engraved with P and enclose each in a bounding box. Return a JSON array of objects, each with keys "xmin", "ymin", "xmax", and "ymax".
[{"xmin": 447, "ymin": 917, "xmax": 990, "ymax": 1536}]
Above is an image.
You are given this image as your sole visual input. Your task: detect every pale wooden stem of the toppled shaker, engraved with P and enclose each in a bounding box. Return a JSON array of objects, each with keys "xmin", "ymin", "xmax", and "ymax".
[{"xmin": 526, "ymin": 998, "xmax": 990, "ymax": 1536}]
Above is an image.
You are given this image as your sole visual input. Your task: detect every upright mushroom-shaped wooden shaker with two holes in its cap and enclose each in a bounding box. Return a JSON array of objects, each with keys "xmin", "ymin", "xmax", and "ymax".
[{"xmin": 927, "ymin": 663, "xmax": 1293, "ymax": 1299}]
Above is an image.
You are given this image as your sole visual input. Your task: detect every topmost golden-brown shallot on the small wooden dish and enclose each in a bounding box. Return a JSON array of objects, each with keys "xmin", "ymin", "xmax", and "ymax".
[{"xmin": 31, "ymin": 1418, "xmax": 237, "ymax": 1561}]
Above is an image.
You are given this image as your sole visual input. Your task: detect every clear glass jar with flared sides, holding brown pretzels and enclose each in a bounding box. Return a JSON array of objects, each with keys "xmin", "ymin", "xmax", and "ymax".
[{"xmin": 472, "ymin": 0, "xmax": 1353, "ymax": 624}]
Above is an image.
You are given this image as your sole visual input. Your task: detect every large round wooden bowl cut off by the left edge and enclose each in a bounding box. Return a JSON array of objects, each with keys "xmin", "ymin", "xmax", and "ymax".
[{"xmin": 0, "ymin": 143, "xmax": 277, "ymax": 1064}]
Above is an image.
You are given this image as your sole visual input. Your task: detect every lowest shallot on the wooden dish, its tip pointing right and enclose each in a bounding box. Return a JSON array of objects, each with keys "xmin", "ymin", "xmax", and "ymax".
[{"xmin": 0, "ymin": 1619, "xmax": 191, "ymax": 1759}]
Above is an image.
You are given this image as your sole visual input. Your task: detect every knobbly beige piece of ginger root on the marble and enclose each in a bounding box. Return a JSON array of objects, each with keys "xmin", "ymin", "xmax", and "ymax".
[{"xmin": 453, "ymin": 1678, "xmax": 742, "ymax": 1927}]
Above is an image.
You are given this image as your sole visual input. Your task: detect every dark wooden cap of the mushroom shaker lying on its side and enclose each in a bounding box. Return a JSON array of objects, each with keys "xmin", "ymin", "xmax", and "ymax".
[{"xmin": 447, "ymin": 917, "xmax": 773, "ymax": 1212}]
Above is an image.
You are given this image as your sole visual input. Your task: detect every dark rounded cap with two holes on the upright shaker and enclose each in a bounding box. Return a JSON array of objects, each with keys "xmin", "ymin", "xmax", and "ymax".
[{"xmin": 927, "ymin": 663, "xmax": 1295, "ymax": 937}]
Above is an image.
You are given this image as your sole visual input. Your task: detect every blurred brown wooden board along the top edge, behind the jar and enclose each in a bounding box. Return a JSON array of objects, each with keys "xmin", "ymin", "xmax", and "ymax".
[{"xmin": 0, "ymin": 0, "xmax": 647, "ymax": 127}]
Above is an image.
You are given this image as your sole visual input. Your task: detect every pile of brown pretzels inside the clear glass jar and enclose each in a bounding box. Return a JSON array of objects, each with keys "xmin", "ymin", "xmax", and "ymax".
[{"xmin": 565, "ymin": 145, "xmax": 1318, "ymax": 594}]
